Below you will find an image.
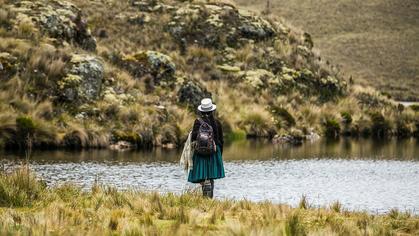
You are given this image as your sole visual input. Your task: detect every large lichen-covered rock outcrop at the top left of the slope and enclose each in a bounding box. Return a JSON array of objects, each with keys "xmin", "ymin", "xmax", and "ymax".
[{"xmin": 10, "ymin": 0, "xmax": 96, "ymax": 51}]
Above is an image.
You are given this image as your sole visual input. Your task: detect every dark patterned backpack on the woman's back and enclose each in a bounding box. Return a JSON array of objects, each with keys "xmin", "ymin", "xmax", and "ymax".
[{"xmin": 195, "ymin": 119, "xmax": 216, "ymax": 156}]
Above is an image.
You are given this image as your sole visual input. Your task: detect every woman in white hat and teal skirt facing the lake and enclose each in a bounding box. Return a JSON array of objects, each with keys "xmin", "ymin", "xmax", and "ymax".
[{"xmin": 188, "ymin": 98, "xmax": 225, "ymax": 198}]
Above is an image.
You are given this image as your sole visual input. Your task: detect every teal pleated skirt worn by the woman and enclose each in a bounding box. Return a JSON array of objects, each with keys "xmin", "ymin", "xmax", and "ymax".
[{"xmin": 188, "ymin": 146, "xmax": 225, "ymax": 183}]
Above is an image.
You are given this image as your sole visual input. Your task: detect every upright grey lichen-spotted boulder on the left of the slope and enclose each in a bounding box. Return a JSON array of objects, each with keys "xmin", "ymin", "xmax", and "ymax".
[{"xmin": 58, "ymin": 54, "xmax": 104, "ymax": 102}]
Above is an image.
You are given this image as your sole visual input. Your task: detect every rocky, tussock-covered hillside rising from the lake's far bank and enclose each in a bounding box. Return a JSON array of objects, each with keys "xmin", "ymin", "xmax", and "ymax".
[{"xmin": 0, "ymin": 0, "xmax": 419, "ymax": 148}]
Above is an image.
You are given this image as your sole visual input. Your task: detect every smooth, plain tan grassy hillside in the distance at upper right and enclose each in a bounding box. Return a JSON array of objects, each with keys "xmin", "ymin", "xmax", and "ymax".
[{"xmin": 237, "ymin": 0, "xmax": 419, "ymax": 100}]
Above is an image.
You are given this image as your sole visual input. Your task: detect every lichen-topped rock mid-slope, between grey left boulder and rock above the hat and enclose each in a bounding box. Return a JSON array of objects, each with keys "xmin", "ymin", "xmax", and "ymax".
[{"xmin": 122, "ymin": 51, "xmax": 176, "ymax": 85}]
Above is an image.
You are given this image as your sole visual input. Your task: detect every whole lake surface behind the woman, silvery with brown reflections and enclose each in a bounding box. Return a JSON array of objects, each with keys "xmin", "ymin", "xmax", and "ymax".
[{"xmin": 1, "ymin": 139, "xmax": 419, "ymax": 214}]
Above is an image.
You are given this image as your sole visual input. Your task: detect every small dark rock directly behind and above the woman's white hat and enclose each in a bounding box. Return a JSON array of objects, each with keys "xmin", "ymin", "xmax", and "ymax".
[{"xmin": 178, "ymin": 81, "xmax": 211, "ymax": 108}]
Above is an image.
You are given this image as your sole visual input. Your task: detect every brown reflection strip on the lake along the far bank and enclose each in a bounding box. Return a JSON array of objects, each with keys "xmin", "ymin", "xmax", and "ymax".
[{"xmin": 2, "ymin": 138, "xmax": 419, "ymax": 162}]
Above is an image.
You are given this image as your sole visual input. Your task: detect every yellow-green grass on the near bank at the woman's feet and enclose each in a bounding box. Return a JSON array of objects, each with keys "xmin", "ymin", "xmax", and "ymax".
[{"xmin": 0, "ymin": 169, "xmax": 419, "ymax": 235}]
